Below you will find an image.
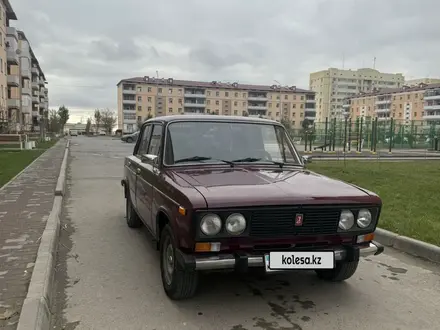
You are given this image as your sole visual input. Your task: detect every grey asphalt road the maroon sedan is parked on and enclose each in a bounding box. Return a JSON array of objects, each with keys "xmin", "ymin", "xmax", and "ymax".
[{"xmin": 53, "ymin": 136, "xmax": 440, "ymax": 330}]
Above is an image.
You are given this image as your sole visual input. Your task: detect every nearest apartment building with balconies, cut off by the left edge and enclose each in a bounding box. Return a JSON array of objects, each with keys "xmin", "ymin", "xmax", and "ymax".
[{"xmin": 0, "ymin": 0, "xmax": 20, "ymax": 131}]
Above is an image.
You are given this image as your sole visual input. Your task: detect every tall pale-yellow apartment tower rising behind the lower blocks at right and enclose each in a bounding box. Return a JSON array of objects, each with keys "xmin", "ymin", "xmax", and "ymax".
[{"xmin": 309, "ymin": 68, "xmax": 405, "ymax": 121}]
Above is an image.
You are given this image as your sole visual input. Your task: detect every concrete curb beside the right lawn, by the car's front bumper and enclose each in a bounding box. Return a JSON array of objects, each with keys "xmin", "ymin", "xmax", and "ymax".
[{"xmin": 374, "ymin": 228, "xmax": 440, "ymax": 263}]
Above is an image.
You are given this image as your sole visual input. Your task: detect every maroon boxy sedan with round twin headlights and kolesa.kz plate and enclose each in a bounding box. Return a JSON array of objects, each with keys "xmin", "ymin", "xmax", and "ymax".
[{"xmin": 121, "ymin": 115, "xmax": 383, "ymax": 300}]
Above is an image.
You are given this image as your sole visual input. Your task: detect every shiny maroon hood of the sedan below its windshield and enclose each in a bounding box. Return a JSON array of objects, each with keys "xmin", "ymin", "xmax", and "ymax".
[{"xmin": 173, "ymin": 167, "xmax": 380, "ymax": 208}]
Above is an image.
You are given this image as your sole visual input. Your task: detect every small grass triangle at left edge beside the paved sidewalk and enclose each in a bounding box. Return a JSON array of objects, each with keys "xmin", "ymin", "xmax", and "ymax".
[{"xmin": 0, "ymin": 140, "xmax": 58, "ymax": 187}]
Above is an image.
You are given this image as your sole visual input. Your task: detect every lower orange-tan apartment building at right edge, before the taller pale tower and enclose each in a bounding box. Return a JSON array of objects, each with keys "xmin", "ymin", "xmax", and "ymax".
[{"xmin": 343, "ymin": 83, "xmax": 440, "ymax": 124}]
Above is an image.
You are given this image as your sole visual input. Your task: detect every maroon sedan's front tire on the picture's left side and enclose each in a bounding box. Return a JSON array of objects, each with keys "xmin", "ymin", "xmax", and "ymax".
[{"xmin": 160, "ymin": 225, "xmax": 199, "ymax": 300}]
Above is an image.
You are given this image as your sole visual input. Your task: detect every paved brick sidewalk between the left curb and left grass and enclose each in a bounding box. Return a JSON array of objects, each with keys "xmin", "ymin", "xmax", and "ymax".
[{"xmin": 0, "ymin": 140, "xmax": 66, "ymax": 330}]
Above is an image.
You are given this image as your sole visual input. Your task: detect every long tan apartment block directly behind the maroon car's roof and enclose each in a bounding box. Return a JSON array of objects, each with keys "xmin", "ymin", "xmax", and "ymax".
[{"xmin": 117, "ymin": 76, "xmax": 316, "ymax": 132}]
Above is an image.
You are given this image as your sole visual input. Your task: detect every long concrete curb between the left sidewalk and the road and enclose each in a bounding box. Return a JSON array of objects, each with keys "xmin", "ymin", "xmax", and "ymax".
[{"xmin": 17, "ymin": 141, "xmax": 70, "ymax": 330}]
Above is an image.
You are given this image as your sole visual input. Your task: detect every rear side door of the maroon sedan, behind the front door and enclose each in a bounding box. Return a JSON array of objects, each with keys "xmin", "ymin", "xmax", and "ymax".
[{"xmin": 133, "ymin": 124, "xmax": 152, "ymax": 229}]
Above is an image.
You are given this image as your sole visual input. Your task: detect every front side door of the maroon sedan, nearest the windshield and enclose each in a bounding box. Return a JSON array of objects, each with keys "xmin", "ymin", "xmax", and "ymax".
[{"xmin": 138, "ymin": 123, "xmax": 163, "ymax": 234}]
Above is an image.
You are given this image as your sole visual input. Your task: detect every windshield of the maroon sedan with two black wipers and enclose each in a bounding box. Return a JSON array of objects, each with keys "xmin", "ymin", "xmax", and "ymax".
[{"xmin": 165, "ymin": 121, "xmax": 300, "ymax": 165}]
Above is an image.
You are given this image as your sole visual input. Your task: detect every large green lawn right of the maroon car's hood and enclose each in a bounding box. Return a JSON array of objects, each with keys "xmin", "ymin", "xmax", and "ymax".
[{"xmin": 308, "ymin": 161, "xmax": 440, "ymax": 246}]
